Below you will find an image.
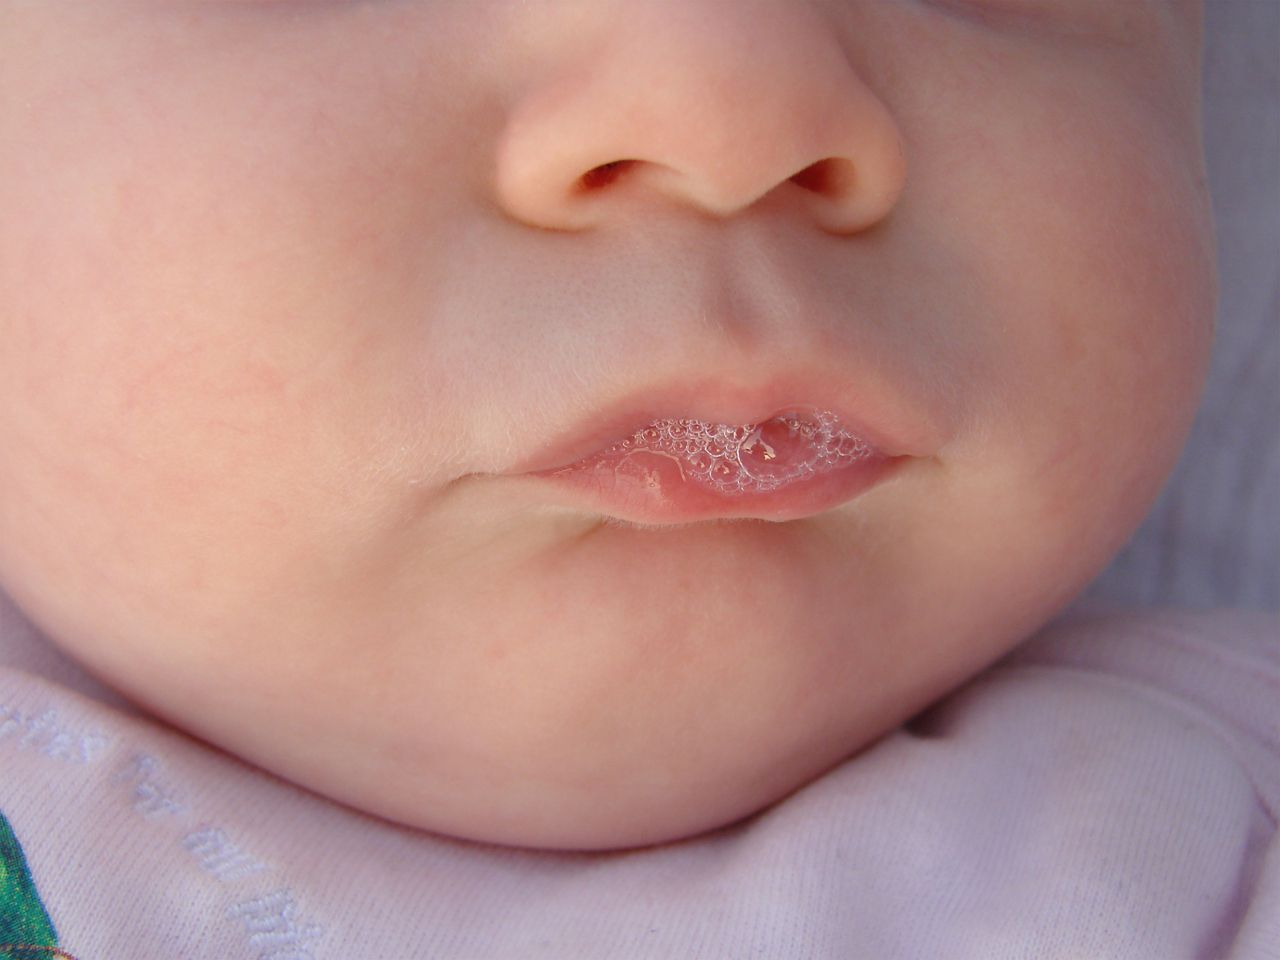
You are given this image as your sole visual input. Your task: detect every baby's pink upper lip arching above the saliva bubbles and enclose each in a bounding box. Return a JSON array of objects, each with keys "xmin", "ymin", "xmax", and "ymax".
[{"xmin": 507, "ymin": 370, "xmax": 941, "ymax": 474}]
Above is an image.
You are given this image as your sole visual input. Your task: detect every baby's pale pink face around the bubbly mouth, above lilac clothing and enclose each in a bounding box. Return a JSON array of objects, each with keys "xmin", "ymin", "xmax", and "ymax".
[{"xmin": 0, "ymin": 0, "xmax": 1215, "ymax": 849}]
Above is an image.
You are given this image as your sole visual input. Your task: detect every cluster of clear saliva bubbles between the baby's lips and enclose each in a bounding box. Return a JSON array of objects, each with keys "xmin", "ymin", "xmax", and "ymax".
[{"xmin": 586, "ymin": 410, "xmax": 876, "ymax": 495}]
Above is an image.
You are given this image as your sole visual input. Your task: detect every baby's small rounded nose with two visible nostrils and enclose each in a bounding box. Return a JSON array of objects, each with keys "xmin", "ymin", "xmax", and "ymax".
[{"xmin": 495, "ymin": 0, "xmax": 906, "ymax": 233}]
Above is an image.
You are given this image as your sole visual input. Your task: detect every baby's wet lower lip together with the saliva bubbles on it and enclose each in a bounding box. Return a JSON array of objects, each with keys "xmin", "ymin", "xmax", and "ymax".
[{"xmin": 527, "ymin": 404, "xmax": 911, "ymax": 526}]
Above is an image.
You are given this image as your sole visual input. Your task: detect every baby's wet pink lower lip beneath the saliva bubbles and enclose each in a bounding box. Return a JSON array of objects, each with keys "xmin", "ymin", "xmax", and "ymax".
[{"xmin": 529, "ymin": 452, "xmax": 910, "ymax": 526}]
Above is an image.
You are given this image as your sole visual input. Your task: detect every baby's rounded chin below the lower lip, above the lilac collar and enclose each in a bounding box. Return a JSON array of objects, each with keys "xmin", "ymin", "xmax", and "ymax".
[{"xmin": 238, "ymin": 526, "xmax": 952, "ymax": 851}]
